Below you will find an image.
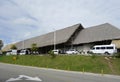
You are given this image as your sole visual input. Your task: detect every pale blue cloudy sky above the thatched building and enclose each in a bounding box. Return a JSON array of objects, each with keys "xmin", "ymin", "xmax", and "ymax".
[{"xmin": 0, "ymin": 0, "xmax": 120, "ymax": 45}]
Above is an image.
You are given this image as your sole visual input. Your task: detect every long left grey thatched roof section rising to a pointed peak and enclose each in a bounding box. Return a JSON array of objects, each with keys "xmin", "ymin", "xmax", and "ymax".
[{"xmin": 16, "ymin": 24, "xmax": 83, "ymax": 49}]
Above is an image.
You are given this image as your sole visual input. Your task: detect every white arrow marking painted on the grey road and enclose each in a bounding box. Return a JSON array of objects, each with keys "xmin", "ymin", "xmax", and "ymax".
[{"xmin": 6, "ymin": 75, "xmax": 42, "ymax": 82}]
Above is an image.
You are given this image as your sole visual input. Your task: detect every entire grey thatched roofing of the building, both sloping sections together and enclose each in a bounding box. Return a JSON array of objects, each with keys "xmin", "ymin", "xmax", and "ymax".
[{"xmin": 3, "ymin": 23, "xmax": 120, "ymax": 51}]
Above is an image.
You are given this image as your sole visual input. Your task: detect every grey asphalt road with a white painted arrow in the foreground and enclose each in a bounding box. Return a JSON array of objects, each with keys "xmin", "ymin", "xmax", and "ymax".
[{"xmin": 0, "ymin": 63, "xmax": 120, "ymax": 82}]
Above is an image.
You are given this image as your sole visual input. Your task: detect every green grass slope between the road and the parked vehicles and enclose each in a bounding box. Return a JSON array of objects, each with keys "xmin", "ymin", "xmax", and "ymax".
[{"xmin": 0, "ymin": 55, "xmax": 120, "ymax": 75}]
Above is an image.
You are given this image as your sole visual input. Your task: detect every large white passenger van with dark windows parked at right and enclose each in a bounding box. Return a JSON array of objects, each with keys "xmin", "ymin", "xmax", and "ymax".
[{"xmin": 90, "ymin": 44, "xmax": 117, "ymax": 55}]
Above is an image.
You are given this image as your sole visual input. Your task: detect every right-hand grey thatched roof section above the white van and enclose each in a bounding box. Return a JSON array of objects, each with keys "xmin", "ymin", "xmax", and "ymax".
[{"xmin": 73, "ymin": 23, "xmax": 120, "ymax": 45}]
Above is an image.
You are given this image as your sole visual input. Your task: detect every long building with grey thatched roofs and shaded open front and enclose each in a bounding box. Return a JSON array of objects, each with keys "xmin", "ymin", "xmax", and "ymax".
[{"xmin": 3, "ymin": 23, "xmax": 120, "ymax": 53}]
